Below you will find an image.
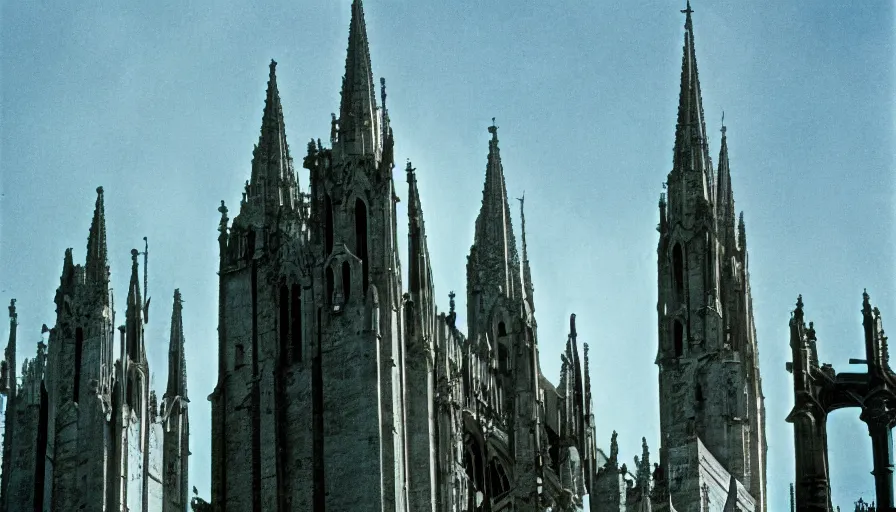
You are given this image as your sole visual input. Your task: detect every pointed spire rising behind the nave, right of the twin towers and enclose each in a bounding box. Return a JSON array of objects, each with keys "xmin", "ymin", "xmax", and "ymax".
[{"xmin": 467, "ymin": 119, "xmax": 522, "ymax": 336}]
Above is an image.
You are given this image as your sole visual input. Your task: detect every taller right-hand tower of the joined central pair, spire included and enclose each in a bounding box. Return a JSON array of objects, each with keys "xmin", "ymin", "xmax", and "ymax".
[{"xmin": 305, "ymin": 0, "xmax": 407, "ymax": 504}]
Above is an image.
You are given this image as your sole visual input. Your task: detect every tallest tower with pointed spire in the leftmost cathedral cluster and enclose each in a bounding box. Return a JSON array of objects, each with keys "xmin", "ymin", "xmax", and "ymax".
[{"xmin": 48, "ymin": 187, "xmax": 115, "ymax": 510}]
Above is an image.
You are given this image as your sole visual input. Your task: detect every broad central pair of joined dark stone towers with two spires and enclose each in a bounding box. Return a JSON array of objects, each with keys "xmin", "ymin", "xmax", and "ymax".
[{"xmin": 211, "ymin": 0, "xmax": 407, "ymax": 510}]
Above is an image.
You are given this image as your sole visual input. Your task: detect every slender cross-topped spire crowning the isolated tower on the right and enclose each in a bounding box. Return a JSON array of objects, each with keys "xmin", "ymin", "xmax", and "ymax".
[{"xmin": 669, "ymin": 1, "xmax": 714, "ymax": 208}]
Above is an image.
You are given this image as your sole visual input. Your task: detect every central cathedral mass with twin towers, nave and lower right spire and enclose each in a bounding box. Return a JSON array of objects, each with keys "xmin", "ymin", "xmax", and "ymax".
[{"xmin": 193, "ymin": 0, "xmax": 602, "ymax": 512}]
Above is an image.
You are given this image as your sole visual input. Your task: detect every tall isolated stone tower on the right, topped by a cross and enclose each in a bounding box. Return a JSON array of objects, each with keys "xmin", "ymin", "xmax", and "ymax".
[{"xmin": 657, "ymin": 4, "xmax": 765, "ymax": 510}]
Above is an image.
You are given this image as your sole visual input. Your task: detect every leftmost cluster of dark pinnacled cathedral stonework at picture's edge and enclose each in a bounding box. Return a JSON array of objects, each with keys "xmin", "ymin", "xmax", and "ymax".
[{"xmin": 0, "ymin": 187, "xmax": 189, "ymax": 512}]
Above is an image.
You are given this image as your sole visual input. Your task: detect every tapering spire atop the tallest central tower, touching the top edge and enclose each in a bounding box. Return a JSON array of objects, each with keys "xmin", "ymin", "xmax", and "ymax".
[{"xmin": 334, "ymin": 0, "xmax": 382, "ymax": 156}]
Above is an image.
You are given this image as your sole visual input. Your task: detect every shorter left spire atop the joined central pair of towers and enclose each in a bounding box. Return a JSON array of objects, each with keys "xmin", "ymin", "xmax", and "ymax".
[{"xmin": 247, "ymin": 60, "xmax": 298, "ymax": 214}]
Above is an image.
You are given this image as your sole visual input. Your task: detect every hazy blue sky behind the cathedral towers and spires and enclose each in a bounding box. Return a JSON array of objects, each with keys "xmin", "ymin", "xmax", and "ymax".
[{"xmin": 0, "ymin": 0, "xmax": 896, "ymax": 510}]
